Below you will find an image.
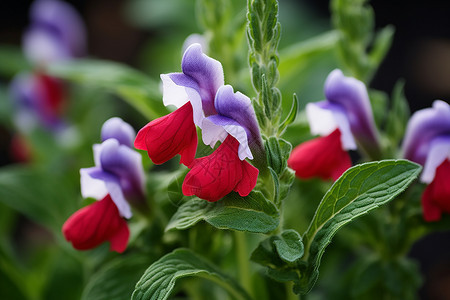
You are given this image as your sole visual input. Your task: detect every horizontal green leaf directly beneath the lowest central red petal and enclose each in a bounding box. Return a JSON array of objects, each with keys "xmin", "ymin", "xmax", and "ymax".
[{"xmin": 166, "ymin": 191, "xmax": 279, "ymax": 233}]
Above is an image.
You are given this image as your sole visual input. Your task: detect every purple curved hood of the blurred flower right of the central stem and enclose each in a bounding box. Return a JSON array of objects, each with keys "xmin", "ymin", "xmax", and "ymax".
[{"xmin": 325, "ymin": 69, "xmax": 378, "ymax": 150}]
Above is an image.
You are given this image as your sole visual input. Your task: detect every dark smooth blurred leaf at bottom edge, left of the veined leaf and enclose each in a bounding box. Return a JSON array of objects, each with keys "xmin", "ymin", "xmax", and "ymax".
[{"xmin": 81, "ymin": 256, "xmax": 150, "ymax": 300}]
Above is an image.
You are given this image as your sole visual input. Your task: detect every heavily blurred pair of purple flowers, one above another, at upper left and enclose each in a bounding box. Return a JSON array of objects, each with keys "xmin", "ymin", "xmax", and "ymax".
[{"xmin": 10, "ymin": 0, "xmax": 86, "ymax": 131}]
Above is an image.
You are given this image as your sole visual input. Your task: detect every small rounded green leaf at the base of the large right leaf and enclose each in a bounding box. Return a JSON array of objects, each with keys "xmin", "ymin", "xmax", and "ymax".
[{"xmin": 274, "ymin": 229, "xmax": 304, "ymax": 263}]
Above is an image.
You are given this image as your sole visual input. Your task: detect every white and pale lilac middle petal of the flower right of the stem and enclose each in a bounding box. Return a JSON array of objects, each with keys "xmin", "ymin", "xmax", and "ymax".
[{"xmin": 306, "ymin": 101, "xmax": 357, "ymax": 150}]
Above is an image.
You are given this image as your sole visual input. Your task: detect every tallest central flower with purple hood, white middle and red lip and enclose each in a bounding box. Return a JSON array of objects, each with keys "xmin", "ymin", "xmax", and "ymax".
[{"xmin": 134, "ymin": 44, "xmax": 224, "ymax": 166}]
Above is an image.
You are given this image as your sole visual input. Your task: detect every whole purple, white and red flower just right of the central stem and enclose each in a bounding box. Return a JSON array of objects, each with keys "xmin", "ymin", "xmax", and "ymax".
[{"xmin": 288, "ymin": 69, "xmax": 379, "ymax": 180}]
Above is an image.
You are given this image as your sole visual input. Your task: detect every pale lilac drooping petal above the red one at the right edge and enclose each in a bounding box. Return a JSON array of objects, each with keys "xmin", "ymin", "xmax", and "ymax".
[{"xmin": 420, "ymin": 135, "xmax": 450, "ymax": 184}]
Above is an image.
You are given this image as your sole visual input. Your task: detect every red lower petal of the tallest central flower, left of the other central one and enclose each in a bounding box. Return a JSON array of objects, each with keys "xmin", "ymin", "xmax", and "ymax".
[{"xmin": 134, "ymin": 103, "xmax": 197, "ymax": 166}]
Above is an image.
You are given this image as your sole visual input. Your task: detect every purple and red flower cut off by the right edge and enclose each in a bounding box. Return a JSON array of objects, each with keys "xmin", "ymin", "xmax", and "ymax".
[{"xmin": 402, "ymin": 100, "xmax": 450, "ymax": 221}]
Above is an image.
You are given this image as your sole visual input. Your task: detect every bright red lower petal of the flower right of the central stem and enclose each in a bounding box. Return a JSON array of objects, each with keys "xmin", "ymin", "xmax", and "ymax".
[{"xmin": 288, "ymin": 129, "xmax": 352, "ymax": 180}]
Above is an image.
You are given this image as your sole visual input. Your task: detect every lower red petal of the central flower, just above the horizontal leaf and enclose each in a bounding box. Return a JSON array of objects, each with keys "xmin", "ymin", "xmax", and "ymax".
[{"xmin": 182, "ymin": 136, "xmax": 259, "ymax": 202}]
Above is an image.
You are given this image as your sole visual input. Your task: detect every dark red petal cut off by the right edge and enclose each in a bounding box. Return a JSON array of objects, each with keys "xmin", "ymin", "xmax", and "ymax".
[{"xmin": 422, "ymin": 159, "xmax": 450, "ymax": 222}]
